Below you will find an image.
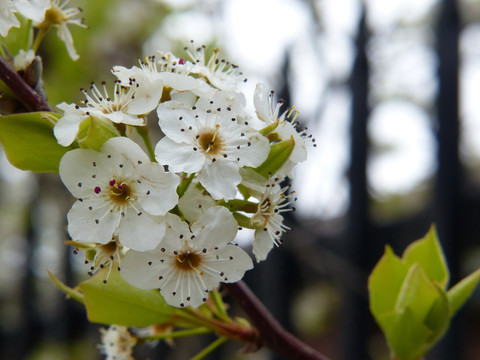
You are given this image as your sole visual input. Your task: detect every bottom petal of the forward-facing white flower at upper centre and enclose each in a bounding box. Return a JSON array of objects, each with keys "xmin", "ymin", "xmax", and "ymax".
[{"xmin": 198, "ymin": 159, "xmax": 242, "ymax": 200}]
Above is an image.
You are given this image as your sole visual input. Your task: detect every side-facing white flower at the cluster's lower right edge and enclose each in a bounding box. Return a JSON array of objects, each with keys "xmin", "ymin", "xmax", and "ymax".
[{"xmin": 251, "ymin": 179, "xmax": 294, "ymax": 262}]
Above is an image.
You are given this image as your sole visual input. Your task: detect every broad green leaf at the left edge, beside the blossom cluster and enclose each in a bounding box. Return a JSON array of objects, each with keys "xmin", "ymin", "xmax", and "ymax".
[{"xmin": 0, "ymin": 112, "xmax": 74, "ymax": 172}]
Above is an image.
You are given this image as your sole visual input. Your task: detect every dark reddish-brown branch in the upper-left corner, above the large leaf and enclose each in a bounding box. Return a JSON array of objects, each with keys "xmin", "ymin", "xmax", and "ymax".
[{"xmin": 0, "ymin": 57, "xmax": 54, "ymax": 112}]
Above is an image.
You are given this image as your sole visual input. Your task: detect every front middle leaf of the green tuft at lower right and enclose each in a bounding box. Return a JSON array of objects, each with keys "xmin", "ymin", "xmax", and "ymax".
[{"xmin": 395, "ymin": 264, "xmax": 439, "ymax": 322}]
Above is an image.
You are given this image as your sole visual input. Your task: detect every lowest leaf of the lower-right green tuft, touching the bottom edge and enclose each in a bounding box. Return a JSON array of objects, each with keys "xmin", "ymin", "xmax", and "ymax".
[{"xmin": 380, "ymin": 307, "xmax": 431, "ymax": 360}]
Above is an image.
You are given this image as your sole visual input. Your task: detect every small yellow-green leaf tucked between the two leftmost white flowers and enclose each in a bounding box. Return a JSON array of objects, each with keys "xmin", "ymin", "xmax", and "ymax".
[{"xmin": 77, "ymin": 116, "xmax": 120, "ymax": 151}]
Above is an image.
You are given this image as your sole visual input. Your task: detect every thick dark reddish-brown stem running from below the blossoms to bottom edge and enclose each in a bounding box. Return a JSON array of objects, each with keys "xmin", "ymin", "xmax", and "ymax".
[{"xmin": 222, "ymin": 281, "xmax": 328, "ymax": 360}]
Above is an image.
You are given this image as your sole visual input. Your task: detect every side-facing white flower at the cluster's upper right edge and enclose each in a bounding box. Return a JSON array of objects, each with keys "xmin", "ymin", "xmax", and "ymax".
[{"xmin": 254, "ymin": 83, "xmax": 314, "ymax": 178}]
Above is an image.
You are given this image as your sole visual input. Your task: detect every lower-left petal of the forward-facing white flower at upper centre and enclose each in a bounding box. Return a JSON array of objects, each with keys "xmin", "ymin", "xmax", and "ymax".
[{"xmin": 155, "ymin": 137, "xmax": 205, "ymax": 174}]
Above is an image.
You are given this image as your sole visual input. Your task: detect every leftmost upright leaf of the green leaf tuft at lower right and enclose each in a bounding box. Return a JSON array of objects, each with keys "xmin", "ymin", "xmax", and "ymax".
[{"xmin": 368, "ymin": 246, "xmax": 408, "ymax": 318}]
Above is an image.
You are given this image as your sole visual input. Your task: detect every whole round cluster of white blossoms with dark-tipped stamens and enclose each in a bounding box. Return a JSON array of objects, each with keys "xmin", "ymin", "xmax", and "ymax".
[{"xmin": 54, "ymin": 43, "xmax": 307, "ymax": 307}]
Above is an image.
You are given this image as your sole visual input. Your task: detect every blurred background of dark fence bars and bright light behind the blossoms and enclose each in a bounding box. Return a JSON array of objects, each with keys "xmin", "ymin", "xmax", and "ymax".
[{"xmin": 0, "ymin": 0, "xmax": 480, "ymax": 360}]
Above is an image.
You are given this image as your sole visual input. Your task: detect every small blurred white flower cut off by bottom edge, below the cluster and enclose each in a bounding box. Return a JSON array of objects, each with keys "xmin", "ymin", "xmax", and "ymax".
[{"xmin": 98, "ymin": 325, "xmax": 137, "ymax": 360}]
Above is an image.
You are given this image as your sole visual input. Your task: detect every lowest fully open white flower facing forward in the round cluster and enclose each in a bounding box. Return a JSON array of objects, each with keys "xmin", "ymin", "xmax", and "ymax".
[{"xmin": 120, "ymin": 206, "xmax": 253, "ymax": 307}]
